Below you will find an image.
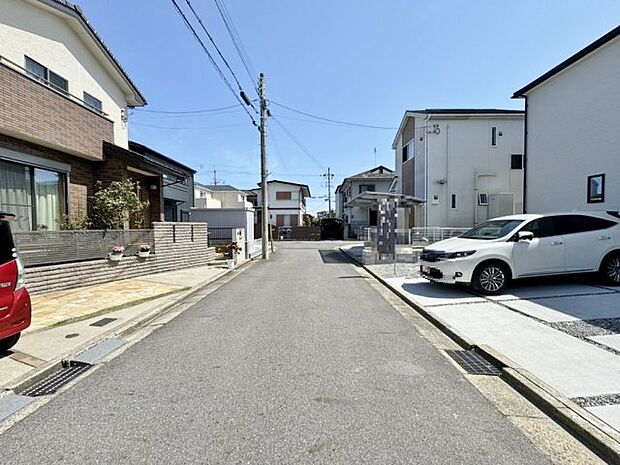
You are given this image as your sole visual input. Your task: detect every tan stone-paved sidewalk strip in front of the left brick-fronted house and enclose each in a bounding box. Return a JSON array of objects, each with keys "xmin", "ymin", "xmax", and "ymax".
[{"xmin": 0, "ymin": 266, "xmax": 228, "ymax": 390}]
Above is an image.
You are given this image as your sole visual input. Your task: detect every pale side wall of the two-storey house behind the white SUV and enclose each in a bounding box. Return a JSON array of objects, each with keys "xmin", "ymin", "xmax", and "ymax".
[{"xmin": 426, "ymin": 116, "xmax": 524, "ymax": 227}]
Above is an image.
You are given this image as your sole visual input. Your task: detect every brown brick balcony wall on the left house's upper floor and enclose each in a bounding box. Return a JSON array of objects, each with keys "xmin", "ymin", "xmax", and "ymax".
[{"xmin": 0, "ymin": 64, "xmax": 114, "ymax": 160}]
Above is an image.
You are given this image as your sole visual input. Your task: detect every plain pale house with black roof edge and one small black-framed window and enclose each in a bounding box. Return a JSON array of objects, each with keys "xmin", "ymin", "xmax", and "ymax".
[{"xmin": 513, "ymin": 26, "xmax": 620, "ymax": 213}]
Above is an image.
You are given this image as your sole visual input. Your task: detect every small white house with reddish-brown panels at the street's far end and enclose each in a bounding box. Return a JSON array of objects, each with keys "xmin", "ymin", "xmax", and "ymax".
[{"xmin": 251, "ymin": 180, "xmax": 310, "ymax": 226}]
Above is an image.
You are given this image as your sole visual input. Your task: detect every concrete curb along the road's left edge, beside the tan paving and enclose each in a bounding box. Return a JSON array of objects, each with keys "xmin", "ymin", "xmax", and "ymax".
[{"xmin": 1, "ymin": 260, "xmax": 255, "ymax": 394}]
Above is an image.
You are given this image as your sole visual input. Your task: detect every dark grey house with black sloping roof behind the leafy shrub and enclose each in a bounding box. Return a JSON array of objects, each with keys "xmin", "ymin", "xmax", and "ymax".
[{"xmin": 129, "ymin": 141, "xmax": 196, "ymax": 221}]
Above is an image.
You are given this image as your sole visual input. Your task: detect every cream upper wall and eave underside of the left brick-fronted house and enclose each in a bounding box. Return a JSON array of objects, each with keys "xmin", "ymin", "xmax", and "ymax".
[{"xmin": 0, "ymin": 0, "xmax": 128, "ymax": 148}]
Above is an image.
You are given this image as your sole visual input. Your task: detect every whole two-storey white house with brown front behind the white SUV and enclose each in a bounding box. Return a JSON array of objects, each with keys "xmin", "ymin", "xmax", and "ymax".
[{"xmin": 392, "ymin": 109, "xmax": 524, "ymax": 228}]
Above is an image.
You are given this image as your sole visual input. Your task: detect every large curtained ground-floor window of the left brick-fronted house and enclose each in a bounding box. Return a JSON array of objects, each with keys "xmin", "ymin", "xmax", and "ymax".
[{"xmin": 0, "ymin": 161, "xmax": 66, "ymax": 231}]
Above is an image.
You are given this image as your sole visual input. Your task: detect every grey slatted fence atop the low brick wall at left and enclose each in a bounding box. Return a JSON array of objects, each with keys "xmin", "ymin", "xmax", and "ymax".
[{"xmin": 15, "ymin": 229, "xmax": 155, "ymax": 267}]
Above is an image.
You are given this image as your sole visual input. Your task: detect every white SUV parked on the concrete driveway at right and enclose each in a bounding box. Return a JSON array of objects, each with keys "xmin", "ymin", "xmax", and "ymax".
[{"xmin": 420, "ymin": 211, "xmax": 620, "ymax": 294}]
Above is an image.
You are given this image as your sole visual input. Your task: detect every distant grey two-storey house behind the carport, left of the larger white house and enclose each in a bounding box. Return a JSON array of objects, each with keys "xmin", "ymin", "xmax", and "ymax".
[{"xmin": 336, "ymin": 166, "xmax": 396, "ymax": 237}]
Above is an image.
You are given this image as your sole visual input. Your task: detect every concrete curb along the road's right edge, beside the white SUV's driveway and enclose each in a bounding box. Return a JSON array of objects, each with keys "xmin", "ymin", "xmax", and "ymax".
[{"xmin": 338, "ymin": 247, "xmax": 620, "ymax": 465}]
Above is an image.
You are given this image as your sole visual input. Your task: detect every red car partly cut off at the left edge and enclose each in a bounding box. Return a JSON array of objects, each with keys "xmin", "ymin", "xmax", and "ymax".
[{"xmin": 0, "ymin": 212, "xmax": 31, "ymax": 353}]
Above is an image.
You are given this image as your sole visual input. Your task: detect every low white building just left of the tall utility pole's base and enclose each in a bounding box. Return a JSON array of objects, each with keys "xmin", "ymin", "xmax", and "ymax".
[{"xmin": 191, "ymin": 183, "xmax": 255, "ymax": 239}]
